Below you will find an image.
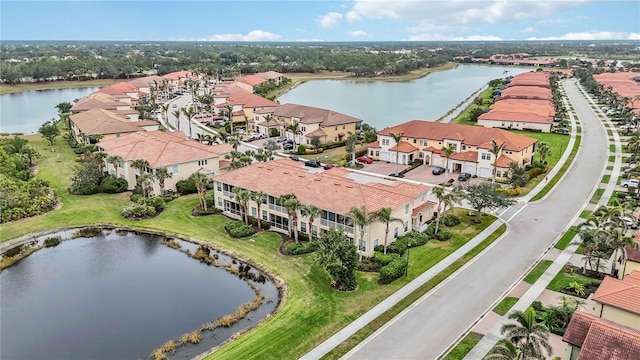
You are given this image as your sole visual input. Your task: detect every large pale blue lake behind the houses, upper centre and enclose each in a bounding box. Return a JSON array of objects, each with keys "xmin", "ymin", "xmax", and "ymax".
[{"xmin": 278, "ymin": 64, "xmax": 532, "ymax": 130}]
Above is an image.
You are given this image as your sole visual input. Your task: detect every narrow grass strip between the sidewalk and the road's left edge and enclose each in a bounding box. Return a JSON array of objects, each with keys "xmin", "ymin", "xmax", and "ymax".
[{"xmin": 322, "ymin": 224, "xmax": 507, "ymax": 360}]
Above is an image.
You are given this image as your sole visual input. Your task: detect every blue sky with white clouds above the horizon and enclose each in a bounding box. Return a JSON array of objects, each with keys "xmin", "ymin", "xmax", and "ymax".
[{"xmin": 0, "ymin": 0, "xmax": 640, "ymax": 43}]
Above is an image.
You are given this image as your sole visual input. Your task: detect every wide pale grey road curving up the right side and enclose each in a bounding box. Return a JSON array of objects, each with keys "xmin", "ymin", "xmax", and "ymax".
[{"xmin": 348, "ymin": 82, "xmax": 608, "ymax": 359}]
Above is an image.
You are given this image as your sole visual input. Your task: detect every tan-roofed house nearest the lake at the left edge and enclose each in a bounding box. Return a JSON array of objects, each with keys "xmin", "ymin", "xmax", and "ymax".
[{"xmin": 69, "ymin": 109, "xmax": 158, "ymax": 143}]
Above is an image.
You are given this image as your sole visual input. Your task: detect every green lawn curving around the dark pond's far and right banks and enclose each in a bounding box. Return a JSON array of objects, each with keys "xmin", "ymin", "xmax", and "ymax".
[{"xmin": 0, "ymin": 135, "xmax": 505, "ymax": 359}]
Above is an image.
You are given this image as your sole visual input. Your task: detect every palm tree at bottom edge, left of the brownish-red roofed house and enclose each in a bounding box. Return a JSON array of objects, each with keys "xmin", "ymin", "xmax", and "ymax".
[{"xmin": 500, "ymin": 307, "xmax": 551, "ymax": 359}]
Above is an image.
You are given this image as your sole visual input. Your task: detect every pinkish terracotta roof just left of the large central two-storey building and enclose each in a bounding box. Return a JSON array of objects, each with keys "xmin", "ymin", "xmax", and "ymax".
[{"xmin": 98, "ymin": 131, "xmax": 233, "ymax": 168}]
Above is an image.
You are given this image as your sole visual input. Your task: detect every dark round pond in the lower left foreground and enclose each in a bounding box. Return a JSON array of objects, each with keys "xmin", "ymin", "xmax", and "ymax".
[{"xmin": 0, "ymin": 229, "xmax": 279, "ymax": 359}]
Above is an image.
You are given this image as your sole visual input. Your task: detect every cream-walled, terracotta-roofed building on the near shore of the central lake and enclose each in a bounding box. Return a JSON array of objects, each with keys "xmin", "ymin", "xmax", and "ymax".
[{"xmin": 254, "ymin": 104, "xmax": 362, "ymax": 144}]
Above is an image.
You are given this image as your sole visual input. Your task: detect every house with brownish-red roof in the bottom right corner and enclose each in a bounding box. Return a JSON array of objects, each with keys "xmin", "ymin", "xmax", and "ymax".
[{"xmin": 562, "ymin": 311, "xmax": 640, "ymax": 360}]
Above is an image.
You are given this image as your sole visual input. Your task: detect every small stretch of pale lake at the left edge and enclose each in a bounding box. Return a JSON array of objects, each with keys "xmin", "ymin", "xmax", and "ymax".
[{"xmin": 0, "ymin": 87, "xmax": 100, "ymax": 134}]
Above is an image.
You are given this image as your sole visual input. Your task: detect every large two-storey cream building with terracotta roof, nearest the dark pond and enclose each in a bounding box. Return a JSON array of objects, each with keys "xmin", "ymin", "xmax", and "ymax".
[{"xmin": 213, "ymin": 158, "xmax": 435, "ymax": 256}]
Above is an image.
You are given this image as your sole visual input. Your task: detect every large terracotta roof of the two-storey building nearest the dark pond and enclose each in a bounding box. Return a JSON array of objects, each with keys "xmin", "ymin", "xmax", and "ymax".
[{"xmin": 214, "ymin": 158, "xmax": 429, "ymax": 214}]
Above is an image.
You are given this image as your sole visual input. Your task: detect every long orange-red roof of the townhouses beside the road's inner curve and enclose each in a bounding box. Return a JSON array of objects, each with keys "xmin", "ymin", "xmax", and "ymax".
[{"xmin": 378, "ymin": 120, "xmax": 537, "ymax": 151}]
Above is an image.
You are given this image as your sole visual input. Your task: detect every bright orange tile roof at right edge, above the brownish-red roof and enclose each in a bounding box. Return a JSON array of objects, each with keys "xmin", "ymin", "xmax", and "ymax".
[{"xmin": 593, "ymin": 276, "xmax": 640, "ymax": 314}]
